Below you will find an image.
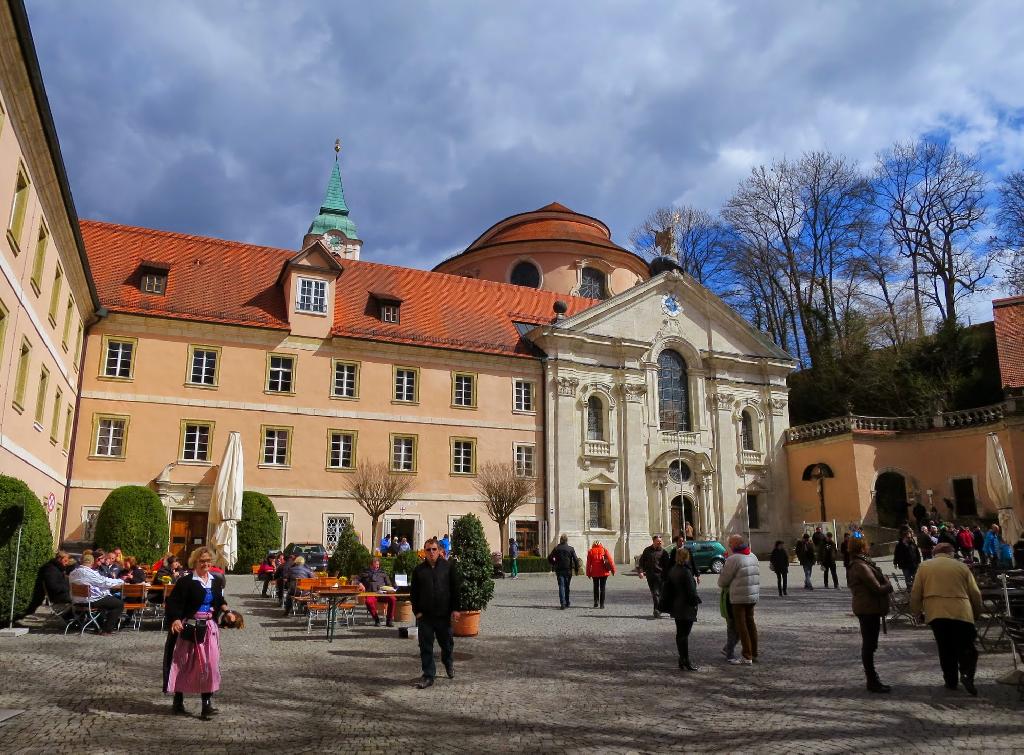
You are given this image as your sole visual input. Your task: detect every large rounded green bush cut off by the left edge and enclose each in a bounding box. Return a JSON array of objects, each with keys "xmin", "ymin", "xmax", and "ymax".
[{"xmin": 0, "ymin": 474, "xmax": 53, "ymax": 627}]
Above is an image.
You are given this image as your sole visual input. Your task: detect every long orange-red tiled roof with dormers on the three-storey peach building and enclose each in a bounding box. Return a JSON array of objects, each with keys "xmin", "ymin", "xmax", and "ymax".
[{"xmin": 81, "ymin": 220, "xmax": 597, "ymax": 356}]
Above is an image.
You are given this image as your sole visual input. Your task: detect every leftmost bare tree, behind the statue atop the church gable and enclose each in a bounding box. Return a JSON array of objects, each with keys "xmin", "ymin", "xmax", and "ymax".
[{"xmin": 630, "ymin": 206, "xmax": 729, "ymax": 291}]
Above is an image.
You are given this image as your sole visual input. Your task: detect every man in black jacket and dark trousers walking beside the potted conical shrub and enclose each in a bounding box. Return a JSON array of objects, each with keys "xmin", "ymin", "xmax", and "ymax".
[{"xmin": 409, "ymin": 538, "xmax": 459, "ymax": 689}]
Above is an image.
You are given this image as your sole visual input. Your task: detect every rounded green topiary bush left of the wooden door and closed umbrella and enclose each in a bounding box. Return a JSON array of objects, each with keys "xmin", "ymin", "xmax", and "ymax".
[{"xmin": 95, "ymin": 485, "xmax": 168, "ymax": 563}]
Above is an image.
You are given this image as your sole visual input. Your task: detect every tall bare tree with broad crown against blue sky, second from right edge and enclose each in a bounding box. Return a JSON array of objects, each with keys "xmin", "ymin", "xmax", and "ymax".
[{"xmin": 874, "ymin": 139, "xmax": 994, "ymax": 329}]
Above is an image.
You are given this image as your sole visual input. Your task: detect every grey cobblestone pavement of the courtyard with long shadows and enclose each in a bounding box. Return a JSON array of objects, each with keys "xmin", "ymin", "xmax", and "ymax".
[{"xmin": 0, "ymin": 564, "xmax": 1024, "ymax": 753}]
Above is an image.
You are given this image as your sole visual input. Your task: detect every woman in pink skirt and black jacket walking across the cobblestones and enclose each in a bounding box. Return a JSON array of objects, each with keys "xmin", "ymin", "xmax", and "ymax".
[{"xmin": 164, "ymin": 548, "xmax": 234, "ymax": 720}]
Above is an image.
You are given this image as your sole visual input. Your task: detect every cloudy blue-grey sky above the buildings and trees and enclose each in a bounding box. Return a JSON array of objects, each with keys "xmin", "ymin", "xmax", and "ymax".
[{"xmin": 22, "ymin": 0, "xmax": 1024, "ymax": 309}]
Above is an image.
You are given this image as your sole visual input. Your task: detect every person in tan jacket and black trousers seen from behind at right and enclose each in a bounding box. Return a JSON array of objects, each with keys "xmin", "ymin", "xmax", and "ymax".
[{"xmin": 910, "ymin": 543, "xmax": 981, "ymax": 695}]
